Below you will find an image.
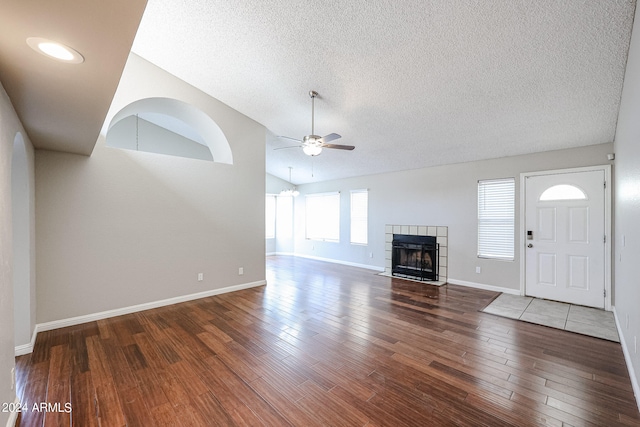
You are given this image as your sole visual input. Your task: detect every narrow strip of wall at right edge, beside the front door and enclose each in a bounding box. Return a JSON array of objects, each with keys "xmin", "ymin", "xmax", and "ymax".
[{"xmin": 614, "ymin": 0, "xmax": 640, "ymax": 405}]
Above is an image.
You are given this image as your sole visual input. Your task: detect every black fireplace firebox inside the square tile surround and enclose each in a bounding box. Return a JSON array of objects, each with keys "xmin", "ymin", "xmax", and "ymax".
[{"xmin": 391, "ymin": 234, "xmax": 439, "ymax": 282}]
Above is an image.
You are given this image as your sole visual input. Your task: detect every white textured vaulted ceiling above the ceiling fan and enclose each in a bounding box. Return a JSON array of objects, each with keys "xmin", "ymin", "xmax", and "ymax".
[{"xmin": 133, "ymin": 0, "xmax": 635, "ymax": 184}]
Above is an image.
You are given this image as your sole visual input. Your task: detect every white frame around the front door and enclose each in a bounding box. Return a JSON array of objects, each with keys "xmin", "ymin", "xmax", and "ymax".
[{"xmin": 516, "ymin": 165, "xmax": 613, "ymax": 311}]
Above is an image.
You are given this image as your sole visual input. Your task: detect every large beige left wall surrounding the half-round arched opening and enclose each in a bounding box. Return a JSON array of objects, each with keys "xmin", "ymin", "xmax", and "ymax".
[{"xmin": 36, "ymin": 58, "xmax": 265, "ymax": 323}]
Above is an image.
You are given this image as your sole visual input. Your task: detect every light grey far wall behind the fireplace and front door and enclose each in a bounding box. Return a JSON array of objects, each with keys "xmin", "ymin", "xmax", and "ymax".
[{"xmin": 295, "ymin": 143, "xmax": 613, "ymax": 290}]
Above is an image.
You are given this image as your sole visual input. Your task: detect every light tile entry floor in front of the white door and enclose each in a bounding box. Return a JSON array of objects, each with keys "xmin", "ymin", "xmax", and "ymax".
[{"xmin": 482, "ymin": 294, "xmax": 620, "ymax": 342}]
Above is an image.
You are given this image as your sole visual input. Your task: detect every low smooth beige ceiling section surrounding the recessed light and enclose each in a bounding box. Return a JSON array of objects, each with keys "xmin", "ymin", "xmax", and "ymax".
[{"xmin": 0, "ymin": 0, "xmax": 146, "ymax": 155}]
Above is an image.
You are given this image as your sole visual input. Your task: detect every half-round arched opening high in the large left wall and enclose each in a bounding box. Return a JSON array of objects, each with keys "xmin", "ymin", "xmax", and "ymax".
[{"xmin": 107, "ymin": 97, "xmax": 233, "ymax": 164}]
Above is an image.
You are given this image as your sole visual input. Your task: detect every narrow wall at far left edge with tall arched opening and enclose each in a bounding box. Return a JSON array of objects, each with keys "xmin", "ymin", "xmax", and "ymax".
[{"xmin": 0, "ymin": 85, "xmax": 35, "ymax": 425}]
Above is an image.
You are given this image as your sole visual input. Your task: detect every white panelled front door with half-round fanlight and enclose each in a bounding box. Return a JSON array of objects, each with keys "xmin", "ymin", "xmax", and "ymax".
[{"xmin": 524, "ymin": 170, "xmax": 605, "ymax": 308}]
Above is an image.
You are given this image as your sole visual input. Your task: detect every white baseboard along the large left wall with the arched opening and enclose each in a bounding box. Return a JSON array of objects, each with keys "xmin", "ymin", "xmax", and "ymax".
[{"xmin": 15, "ymin": 280, "xmax": 267, "ymax": 356}]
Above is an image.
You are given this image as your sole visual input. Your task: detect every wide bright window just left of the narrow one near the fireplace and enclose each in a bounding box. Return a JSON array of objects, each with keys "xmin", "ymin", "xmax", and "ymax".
[{"xmin": 305, "ymin": 193, "xmax": 340, "ymax": 242}]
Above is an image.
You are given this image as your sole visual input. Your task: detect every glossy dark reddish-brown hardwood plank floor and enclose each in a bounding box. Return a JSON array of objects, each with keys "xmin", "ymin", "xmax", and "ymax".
[{"xmin": 17, "ymin": 257, "xmax": 640, "ymax": 427}]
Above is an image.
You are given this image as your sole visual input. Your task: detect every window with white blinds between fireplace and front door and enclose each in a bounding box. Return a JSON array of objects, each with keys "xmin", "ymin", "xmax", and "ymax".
[{"xmin": 478, "ymin": 178, "xmax": 516, "ymax": 261}]
